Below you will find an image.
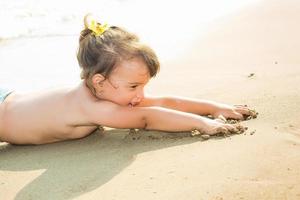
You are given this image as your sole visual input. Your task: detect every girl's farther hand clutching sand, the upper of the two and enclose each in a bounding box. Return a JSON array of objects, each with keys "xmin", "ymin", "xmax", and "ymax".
[{"xmin": 213, "ymin": 105, "xmax": 257, "ymax": 121}]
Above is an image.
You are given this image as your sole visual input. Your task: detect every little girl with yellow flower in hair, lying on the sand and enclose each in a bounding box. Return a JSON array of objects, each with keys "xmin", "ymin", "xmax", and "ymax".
[{"xmin": 0, "ymin": 16, "xmax": 251, "ymax": 144}]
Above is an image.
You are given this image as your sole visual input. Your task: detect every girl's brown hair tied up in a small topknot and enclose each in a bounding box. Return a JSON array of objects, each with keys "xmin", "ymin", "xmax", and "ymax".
[{"xmin": 77, "ymin": 15, "xmax": 160, "ymax": 82}]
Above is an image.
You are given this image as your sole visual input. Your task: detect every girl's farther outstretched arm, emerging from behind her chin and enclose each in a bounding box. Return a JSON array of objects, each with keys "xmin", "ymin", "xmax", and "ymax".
[{"xmin": 139, "ymin": 97, "xmax": 251, "ymax": 119}]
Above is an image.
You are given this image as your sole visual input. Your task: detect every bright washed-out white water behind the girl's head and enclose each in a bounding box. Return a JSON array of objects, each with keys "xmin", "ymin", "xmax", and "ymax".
[{"xmin": 0, "ymin": 0, "xmax": 258, "ymax": 91}]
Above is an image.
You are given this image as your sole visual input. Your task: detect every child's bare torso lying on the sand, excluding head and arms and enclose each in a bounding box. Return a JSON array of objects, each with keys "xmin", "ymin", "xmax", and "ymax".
[{"xmin": 0, "ymin": 85, "xmax": 97, "ymax": 144}]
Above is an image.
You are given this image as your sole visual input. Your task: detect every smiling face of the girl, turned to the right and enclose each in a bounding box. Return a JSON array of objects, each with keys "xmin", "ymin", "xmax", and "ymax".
[{"xmin": 101, "ymin": 58, "xmax": 150, "ymax": 106}]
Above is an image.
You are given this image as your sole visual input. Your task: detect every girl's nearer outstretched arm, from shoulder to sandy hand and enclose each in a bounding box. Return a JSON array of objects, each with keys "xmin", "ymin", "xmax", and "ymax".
[{"xmin": 87, "ymin": 102, "xmax": 236, "ymax": 134}]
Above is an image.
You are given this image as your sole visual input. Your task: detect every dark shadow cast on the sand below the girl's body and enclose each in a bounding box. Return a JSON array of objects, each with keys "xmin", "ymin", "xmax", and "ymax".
[{"xmin": 0, "ymin": 129, "xmax": 221, "ymax": 200}]
